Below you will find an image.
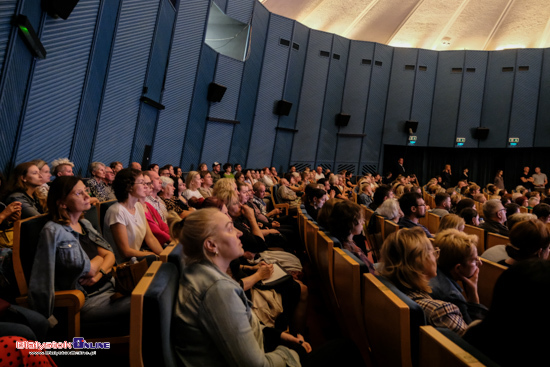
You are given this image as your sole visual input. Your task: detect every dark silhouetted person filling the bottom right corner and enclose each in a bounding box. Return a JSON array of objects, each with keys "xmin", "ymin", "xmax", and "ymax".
[{"xmin": 464, "ymin": 259, "xmax": 550, "ymax": 367}]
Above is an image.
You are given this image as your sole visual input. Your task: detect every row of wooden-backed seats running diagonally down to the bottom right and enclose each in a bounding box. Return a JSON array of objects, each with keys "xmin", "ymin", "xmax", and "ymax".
[{"xmin": 298, "ymin": 209, "xmax": 498, "ymax": 367}]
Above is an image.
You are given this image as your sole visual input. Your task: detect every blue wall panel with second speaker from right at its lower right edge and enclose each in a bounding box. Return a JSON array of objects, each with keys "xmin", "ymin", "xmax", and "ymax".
[{"xmin": 384, "ymin": 48, "xmax": 420, "ymax": 145}]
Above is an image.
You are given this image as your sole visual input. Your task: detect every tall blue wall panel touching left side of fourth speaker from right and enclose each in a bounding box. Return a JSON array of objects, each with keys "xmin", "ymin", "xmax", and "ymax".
[{"xmin": 246, "ymin": 14, "xmax": 294, "ymax": 167}]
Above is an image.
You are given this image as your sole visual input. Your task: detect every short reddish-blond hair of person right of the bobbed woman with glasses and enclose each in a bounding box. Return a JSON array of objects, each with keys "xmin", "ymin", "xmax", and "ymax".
[{"xmin": 434, "ymin": 228, "xmax": 478, "ymax": 271}]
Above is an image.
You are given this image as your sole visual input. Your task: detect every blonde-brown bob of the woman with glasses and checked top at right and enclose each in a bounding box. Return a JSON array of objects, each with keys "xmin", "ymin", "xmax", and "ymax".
[{"xmin": 379, "ymin": 227, "xmax": 432, "ymax": 293}]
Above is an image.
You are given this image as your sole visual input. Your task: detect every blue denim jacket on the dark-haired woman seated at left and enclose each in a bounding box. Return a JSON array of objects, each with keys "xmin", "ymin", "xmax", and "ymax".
[{"xmin": 29, "ymin": 219, "xmax": 113, "ymax": 317}]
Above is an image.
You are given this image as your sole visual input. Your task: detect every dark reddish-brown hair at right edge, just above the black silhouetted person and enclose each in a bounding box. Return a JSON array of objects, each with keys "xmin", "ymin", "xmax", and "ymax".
[{"xmin": 506, "ymin": 219, "xmax": 550, "ymax": 260}]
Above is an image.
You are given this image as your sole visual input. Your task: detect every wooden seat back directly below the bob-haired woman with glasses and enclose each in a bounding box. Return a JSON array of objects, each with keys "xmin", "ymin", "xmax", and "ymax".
[{"xmin": 363, "ymin": 273, "xmax": 425, "ymax": 367}]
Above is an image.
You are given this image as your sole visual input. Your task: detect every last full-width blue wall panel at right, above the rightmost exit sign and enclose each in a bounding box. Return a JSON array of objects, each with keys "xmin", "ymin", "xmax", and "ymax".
[{"xmin": 508, "ymin": 49, "xmax": 542, "ymax": 147}]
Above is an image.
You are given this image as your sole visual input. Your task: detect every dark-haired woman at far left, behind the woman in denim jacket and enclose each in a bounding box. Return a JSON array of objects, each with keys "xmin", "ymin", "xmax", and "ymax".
[{"xmin": 4, "ymin": 162, "xmax": 46, "ymax": 219}]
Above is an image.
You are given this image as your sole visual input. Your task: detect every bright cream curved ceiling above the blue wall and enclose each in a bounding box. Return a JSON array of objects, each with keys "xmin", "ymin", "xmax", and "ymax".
[{"xmin": 260, "ymin": 0, "xmax": 550, "ymax": 50}]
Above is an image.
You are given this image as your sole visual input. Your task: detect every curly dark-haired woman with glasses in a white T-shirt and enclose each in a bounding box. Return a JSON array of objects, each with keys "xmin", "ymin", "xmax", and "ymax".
[{"xmin": 103, "ymin": 168, "xmax": 162, "ymax": 263}]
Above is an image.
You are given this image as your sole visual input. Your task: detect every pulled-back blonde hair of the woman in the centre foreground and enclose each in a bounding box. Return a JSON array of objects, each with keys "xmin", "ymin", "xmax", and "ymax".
[{"xmin": 179, "ymin": 208, "xmax": 220, "ymax": 265}]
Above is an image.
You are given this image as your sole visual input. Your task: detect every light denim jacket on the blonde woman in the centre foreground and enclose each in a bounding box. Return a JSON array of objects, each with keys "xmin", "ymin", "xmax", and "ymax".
[{"xmin": 172, "ymin": 262, "xmax": 300, "ymax": 367}]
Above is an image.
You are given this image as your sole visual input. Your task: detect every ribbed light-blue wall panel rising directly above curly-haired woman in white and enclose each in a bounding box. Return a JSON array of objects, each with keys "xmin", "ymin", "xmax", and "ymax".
[{"xmin": 93, "ymin": 0, "xmax": 159, "ymax": 165}]
